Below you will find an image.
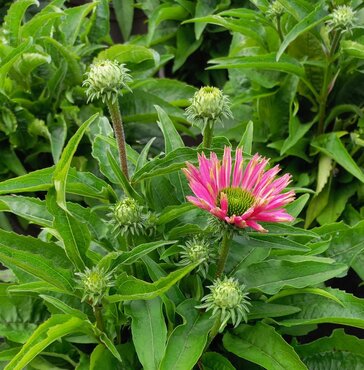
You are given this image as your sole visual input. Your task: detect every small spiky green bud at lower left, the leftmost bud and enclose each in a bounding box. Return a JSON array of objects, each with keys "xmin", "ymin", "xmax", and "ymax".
[{"xmin": 76, "ymin": 266, "xmax": 113, "ymax": 306}]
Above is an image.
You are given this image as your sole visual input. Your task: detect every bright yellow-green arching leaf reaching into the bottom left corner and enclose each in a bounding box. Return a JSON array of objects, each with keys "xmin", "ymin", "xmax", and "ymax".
[{"xmin": 5, "ymin": 315, "xmax": 91, "ymax": 370}]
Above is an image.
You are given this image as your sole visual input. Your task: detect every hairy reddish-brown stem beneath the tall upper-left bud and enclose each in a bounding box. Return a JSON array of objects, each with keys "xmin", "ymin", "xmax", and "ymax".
[{"xmin": 107, "ymin": 99, "xmax": 129, "ymax": 179}]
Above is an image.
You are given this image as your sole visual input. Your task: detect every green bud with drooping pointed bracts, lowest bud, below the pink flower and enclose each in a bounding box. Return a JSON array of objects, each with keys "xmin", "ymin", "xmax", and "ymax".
[{"xmin": 197, "ymin": 276, "xmax": 250, "ymax": 332}]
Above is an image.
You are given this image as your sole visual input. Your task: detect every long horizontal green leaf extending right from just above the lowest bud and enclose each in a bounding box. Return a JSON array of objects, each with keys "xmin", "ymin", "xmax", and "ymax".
[{"xmin": 235, "ymin": 257, "xmax": 348, "ymax": 294}]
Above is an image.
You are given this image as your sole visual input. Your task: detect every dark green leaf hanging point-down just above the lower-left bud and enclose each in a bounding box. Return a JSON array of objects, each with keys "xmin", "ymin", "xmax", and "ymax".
[{"xmin": 47, "ymin": 189, "xmax": 91, "ymax": 271}]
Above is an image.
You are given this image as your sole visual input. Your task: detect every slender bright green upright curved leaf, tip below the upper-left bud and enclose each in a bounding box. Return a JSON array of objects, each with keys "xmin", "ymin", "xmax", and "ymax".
[{"xmin": 53, "ymin": 114, "xmax": 98, "ymax": 210}]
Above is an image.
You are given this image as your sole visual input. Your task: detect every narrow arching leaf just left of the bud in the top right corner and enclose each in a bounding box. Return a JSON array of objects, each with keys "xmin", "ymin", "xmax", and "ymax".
[{"xmin": 276, "ymin": 4, "xmax": 329, "ymax": 61}]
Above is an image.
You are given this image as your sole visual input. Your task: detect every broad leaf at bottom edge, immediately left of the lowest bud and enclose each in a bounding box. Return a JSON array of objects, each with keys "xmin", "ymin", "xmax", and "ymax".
[{"xmin": 159, "ymin": 299, "xmax": 214, "ymax": 370}]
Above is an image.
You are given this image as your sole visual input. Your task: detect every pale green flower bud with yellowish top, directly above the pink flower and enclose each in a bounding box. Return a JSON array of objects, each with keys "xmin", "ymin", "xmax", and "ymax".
[{"xmin": 186, "ymin": 86, "xmax": 232, "ymax": 129}]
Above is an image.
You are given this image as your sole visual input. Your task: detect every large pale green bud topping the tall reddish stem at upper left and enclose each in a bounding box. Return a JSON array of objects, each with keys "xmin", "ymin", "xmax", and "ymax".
[{"xmin": 83, "ymin": 59, "xmax": 132, "ymax": 103}]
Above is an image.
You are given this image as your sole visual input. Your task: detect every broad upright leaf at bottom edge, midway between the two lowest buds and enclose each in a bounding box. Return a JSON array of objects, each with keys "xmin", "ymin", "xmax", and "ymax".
[{"xmin": 128, "ymin": 298, "xmax": 167, "ymax": 370}]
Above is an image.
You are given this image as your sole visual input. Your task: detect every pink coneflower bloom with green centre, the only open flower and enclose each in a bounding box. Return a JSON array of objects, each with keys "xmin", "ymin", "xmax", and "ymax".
[{"xmin": 183, "ymin": 147, "xmax": 295, "ymax": 232}]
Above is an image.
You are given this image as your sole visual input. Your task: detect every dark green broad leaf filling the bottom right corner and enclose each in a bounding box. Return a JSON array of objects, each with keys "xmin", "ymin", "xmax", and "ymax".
[{"xmin": 294, "ymin": 329, "xmax": 364, "ymax": 370}]
